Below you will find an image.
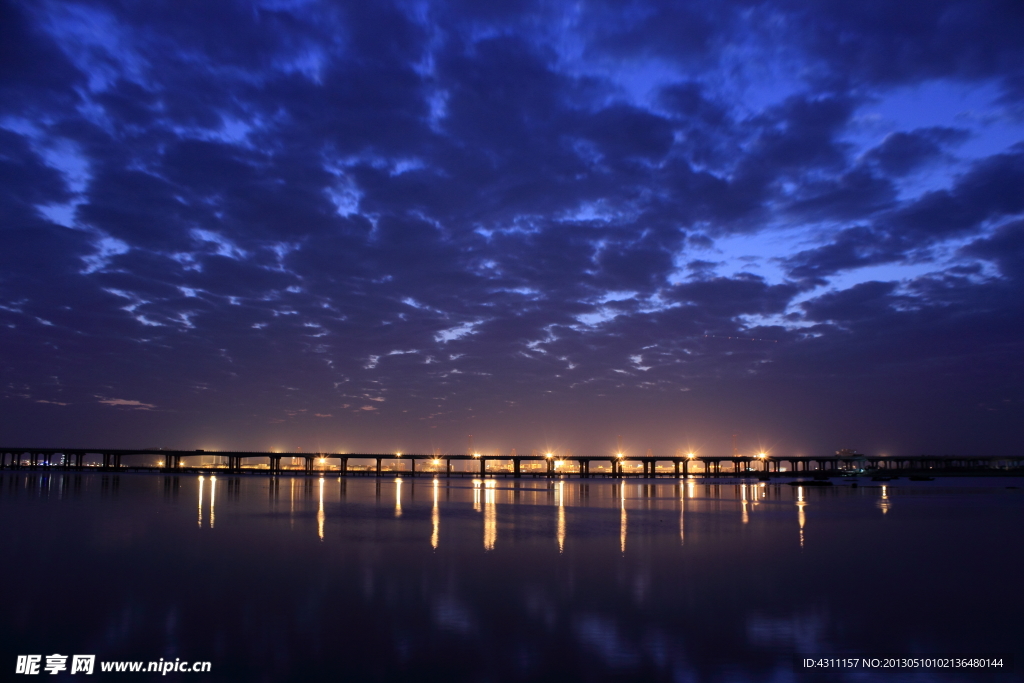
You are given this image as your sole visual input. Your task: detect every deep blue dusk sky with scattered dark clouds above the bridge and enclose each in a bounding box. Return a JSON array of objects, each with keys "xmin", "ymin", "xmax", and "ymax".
[{"xmin": 0, "ymin": 0, "xmax": 1024, "ymax": 455}]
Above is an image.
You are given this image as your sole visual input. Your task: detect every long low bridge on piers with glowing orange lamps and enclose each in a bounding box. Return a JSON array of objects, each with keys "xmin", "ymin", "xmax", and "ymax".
[{"xmin": 0, "ymin": 447, "xmax": 1024, "ymax": 477}]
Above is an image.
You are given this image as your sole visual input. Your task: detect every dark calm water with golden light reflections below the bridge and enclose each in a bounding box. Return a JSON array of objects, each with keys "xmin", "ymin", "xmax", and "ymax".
[{"xmin": 0, "ymin": 472, "xmax": 1024, "ymax": 683}]
